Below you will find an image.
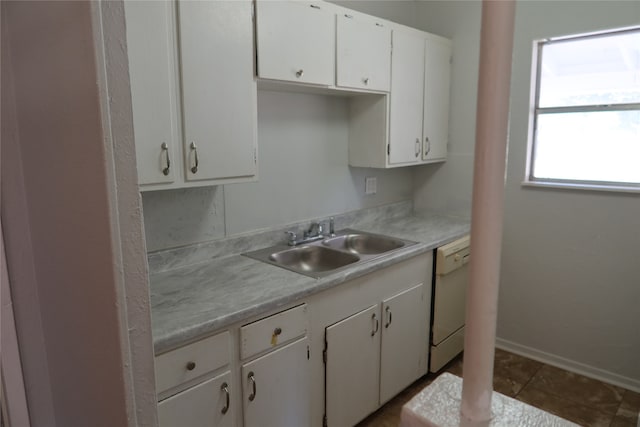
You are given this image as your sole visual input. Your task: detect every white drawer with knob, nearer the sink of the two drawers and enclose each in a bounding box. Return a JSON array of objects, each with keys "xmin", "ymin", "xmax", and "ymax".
[{"xmin": 240, "ymin": 304, "xmax": 308, "ymax": 359}]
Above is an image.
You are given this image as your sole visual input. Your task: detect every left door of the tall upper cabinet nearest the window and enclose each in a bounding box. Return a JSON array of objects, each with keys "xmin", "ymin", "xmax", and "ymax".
[{"xmin": 389, "ymin": 30, "xmax": 424, "ymax": 166}]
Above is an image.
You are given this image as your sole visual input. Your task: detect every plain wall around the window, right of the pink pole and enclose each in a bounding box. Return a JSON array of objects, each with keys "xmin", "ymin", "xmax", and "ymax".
[{"xmin": 498, "ymin": 1, "xmax": 640, "ymax": 388}]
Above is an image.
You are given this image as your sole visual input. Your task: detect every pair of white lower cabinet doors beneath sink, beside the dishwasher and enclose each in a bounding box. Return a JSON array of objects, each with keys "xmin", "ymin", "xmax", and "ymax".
[{"xmin": 325, "ymin": 283, "xmax": 429, "ymax": 427}]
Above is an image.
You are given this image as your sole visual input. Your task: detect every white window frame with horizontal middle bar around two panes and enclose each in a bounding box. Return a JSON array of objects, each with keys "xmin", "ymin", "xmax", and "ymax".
[{"xmin": 522, "ymin": 27, "xmax": 640, "ymax": 193}]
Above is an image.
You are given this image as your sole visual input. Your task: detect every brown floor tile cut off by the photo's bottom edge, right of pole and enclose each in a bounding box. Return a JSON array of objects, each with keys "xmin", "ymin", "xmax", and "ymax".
[{"xmin": 516, "ymin": 385, "xmax": 614, "ymax": 427}]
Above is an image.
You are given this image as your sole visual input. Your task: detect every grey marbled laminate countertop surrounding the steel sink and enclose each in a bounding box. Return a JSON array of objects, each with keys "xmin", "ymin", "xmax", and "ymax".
[{"xmin": 149, "ymin": 211, "xmax": 470, "ymax": 354}]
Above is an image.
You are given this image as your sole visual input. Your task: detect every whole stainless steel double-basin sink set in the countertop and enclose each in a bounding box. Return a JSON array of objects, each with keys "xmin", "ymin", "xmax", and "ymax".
[{"xmin": 244, "ymin": 229, "xmax": 416, "ymax": 278}]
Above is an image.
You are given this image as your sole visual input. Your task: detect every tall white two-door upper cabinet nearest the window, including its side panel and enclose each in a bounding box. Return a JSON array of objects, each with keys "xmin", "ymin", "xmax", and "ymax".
[{"xmin": 349, "ymin": 27, "xmax": 451, "ymax": 168}]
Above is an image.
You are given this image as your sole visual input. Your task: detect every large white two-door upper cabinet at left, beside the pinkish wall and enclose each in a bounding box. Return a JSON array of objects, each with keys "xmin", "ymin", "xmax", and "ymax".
[{"xmin": 125, "ymin": 0, "xmax": 257, "ymax": 190}]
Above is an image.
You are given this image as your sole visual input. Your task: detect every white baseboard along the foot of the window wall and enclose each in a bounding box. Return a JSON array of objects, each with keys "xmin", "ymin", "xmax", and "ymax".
[{"xmin": 496, "ymin": 338, "xmax": 640, "ymax": 393}]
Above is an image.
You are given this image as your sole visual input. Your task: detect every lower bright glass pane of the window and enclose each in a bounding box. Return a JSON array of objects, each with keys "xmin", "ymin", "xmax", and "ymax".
[{"xmin": 533, "ymin": 110, "xmax": 640, "ymax": 183}]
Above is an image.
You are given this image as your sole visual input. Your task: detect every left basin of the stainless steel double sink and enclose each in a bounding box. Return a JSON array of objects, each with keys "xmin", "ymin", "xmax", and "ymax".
[{"xmin": 269, "ymin": 245, "xmax": 360, "ymax": 272}]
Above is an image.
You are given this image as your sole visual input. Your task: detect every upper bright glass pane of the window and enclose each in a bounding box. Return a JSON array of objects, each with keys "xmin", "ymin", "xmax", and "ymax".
[{"xmin": 539, "ymin": 30, "xmax": 640, "ymax": 107}]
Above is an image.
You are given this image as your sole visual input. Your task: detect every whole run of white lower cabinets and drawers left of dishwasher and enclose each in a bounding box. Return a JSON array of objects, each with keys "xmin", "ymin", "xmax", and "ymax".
[{"xmin": 155, "ymin": 253, "xmax": 433, "ymax": 427}]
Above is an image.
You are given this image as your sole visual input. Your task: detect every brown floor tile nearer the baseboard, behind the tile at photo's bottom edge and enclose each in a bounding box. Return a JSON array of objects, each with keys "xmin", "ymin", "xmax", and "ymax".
[{"xmin": 525, "ymin": 365, "xmax": 625, "ymax": 415}]
